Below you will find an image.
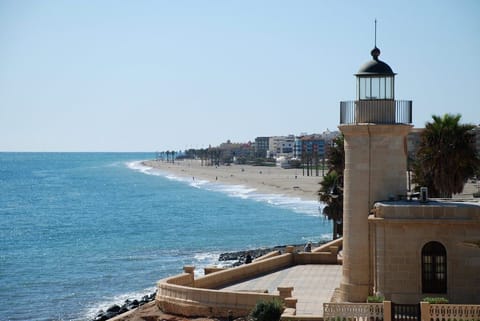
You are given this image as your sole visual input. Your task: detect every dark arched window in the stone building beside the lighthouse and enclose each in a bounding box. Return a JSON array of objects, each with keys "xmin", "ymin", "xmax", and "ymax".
[{"xmin": 422, "ymin": 242, "xmax": 447, "ymax": 293}]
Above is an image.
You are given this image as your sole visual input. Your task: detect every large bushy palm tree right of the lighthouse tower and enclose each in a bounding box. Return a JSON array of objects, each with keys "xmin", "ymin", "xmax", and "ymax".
[{"xmin": 413, "ymin": 114, "xmax": 480, "ymax": 198}]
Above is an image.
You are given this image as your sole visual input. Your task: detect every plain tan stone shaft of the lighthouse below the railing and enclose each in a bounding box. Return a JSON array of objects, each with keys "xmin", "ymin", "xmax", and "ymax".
[{"xmin": 339, "ymin": 124, "xmax": 411, "ymax": 302}]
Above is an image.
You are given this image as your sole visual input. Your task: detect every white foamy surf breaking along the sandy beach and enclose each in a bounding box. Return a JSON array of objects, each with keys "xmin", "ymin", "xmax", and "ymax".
[{"xmin": 126, "ymin": 161, "xmax": 324, "ymax": 216}]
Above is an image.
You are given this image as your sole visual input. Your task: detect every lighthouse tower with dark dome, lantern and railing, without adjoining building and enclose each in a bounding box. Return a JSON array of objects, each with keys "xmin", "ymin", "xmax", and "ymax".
[{"xmin": 339, "ymin": 46, "xmax": 412, "ymax": 302}]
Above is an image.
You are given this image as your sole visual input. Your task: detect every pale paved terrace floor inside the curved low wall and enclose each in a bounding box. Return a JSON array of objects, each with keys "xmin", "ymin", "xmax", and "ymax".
[{"xmin": 224, "ymin": 265, "xmax": 342, "ymax": 316}]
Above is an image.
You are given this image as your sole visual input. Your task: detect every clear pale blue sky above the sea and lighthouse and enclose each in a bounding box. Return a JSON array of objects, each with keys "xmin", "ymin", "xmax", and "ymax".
[{"xmin": 0, "ymin": 0, "xmax": 480, "ymax": 151}]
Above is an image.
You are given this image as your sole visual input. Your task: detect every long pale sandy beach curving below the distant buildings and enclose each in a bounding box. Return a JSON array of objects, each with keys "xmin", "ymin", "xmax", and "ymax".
[{"xmin": 144, "ymin": 160, "xmax": 322, "ymax": 200}]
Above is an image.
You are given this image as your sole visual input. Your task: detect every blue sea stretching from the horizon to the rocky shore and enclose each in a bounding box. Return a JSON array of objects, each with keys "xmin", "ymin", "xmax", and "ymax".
[{"xmin": 0, "ymin": 153, "xmax": 331, "ymax": 321}]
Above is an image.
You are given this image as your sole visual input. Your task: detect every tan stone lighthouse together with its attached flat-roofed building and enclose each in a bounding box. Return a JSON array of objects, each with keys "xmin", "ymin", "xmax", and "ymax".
[{"xmin": 339, "ymin": 47, "xmax": 480, "ymax": 304}]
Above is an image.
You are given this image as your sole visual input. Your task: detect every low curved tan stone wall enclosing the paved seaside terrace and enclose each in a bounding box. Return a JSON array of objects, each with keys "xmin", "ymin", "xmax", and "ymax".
[{"xmin": 155, "ymin": 241, "xmax": 338, "ymax": 321}]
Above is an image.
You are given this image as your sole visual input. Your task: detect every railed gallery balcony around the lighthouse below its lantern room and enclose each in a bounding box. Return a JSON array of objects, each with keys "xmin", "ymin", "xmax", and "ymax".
[{"xmin": 340, "ymin": 100, "xmax": 412, "ymax": 125}]
